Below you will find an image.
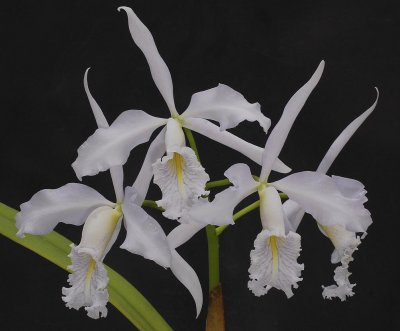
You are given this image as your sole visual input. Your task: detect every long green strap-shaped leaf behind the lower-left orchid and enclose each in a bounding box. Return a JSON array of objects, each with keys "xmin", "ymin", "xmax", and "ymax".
[{"xmin": 0, "ymin": 202, "xmax": 172, "ymax": 331}]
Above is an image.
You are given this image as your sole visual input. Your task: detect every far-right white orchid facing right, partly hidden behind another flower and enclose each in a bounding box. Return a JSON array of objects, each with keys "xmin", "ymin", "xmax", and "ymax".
[{"xmin": 283, "ymin": 90, "xmax": 379, "ymax": 301}]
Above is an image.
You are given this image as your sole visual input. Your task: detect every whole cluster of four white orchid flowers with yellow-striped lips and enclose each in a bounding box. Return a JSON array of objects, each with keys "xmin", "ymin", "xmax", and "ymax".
[{"xmin": 17, "ymin": 7, "xmax": 378, "ymax": 318}]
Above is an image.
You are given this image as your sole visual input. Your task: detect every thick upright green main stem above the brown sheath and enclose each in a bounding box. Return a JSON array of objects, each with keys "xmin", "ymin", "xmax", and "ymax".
[{"xmin": 206, "ymin": 225, "xmax": 220, "ymax": 293}]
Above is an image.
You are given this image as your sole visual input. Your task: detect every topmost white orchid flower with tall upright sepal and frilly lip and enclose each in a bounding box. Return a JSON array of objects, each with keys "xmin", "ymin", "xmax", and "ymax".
[{"xmin": 72, "ymin": 7, "xmax": 290, "ymax": 219}]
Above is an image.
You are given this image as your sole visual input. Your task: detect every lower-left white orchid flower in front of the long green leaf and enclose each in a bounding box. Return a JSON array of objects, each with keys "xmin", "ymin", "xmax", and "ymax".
[{"xmin": 16, "ymin": 71, "xmax": 202, "ymax": 318}]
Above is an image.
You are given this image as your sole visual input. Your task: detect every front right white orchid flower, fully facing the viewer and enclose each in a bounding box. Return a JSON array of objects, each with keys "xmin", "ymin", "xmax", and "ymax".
[{"xmin": 181, "ymin": 61, "xmax": 372, "ymax": 297}]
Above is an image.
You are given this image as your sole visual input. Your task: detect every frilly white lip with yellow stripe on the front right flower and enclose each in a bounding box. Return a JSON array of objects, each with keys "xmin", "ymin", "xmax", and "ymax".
[{"xmin": 248, "ymin": 230, "xmax": 304, "ymax": 298}]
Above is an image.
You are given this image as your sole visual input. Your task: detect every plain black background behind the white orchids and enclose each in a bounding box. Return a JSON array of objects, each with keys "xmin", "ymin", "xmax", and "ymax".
[{"xmin": 0, "ymin": 0, "xmax": 400, "ymax": 331}]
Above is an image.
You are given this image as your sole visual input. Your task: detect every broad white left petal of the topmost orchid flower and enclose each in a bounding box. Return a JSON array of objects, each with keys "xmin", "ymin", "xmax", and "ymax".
[{"xmin": 72, "ymin": 110, "xmax": 166, "ymax": 179}]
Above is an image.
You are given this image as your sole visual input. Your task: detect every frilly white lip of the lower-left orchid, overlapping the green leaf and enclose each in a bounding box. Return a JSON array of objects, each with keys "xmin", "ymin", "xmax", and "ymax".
[{"xmin": 62, "ymin": 244, "xmax": 108, "ymax": 319}]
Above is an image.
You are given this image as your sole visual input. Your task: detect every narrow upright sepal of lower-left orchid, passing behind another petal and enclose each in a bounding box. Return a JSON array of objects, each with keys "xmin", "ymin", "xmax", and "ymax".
[{"xmin": 83, "ymin": 68, "xmax": 124, "ymax": 202}]
